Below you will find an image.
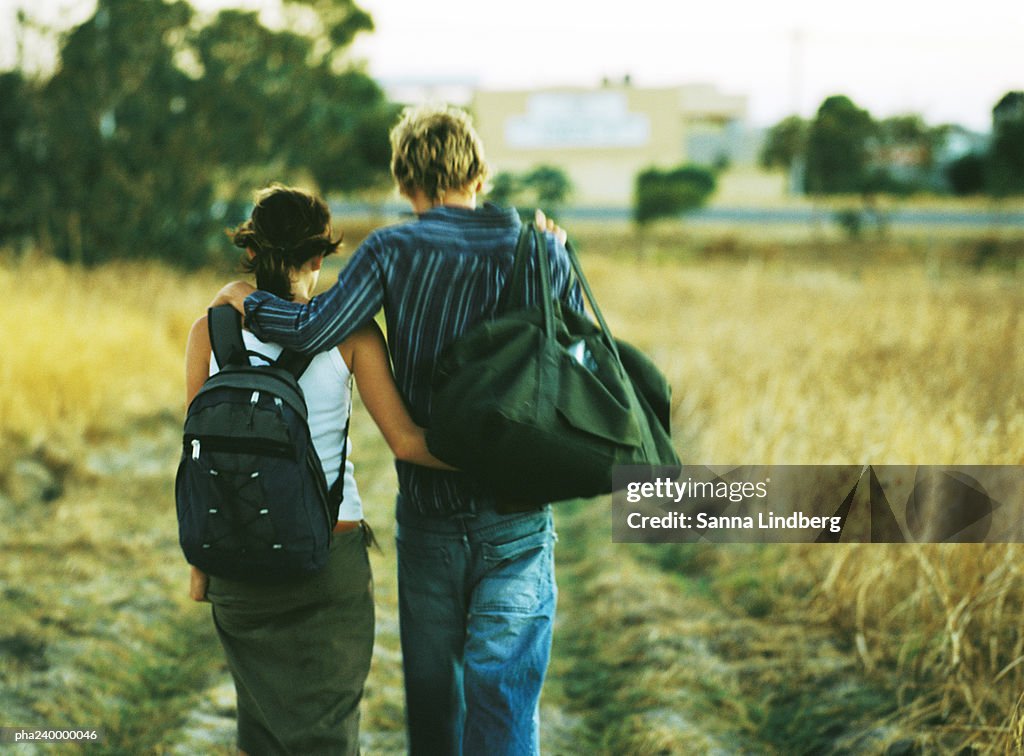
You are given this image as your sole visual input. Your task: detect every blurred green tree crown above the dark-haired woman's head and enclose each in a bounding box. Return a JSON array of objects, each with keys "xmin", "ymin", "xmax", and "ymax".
[{"xmin": 188, "ymin": 3, "xmax": 396, "ymax": 192}]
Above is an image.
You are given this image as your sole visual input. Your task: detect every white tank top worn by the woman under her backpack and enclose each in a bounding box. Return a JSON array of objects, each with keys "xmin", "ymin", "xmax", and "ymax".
[{"xmin": 210, "ymin": 331, "xmax": 362, "ymax": 520}]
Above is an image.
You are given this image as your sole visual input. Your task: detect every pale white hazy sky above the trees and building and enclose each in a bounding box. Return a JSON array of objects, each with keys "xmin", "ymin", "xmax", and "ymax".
[{"xmin": 0, "ymin": 0, "xmax": 1024, "ymax": 129}]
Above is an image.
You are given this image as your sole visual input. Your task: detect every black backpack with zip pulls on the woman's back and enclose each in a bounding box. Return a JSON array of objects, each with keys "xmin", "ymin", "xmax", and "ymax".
[{"xmin": 174, "ymin": 306, "xmax": 351, "ymax": 581}]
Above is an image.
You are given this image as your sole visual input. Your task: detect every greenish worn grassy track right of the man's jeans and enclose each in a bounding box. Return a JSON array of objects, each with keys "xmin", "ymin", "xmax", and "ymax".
[{"xmin": 552, "ymin": 503, "xmax": 900, "ymax": 754}]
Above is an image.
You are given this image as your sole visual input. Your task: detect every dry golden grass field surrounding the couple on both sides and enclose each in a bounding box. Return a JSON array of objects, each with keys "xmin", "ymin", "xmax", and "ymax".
[{"xmin": 0, "ymin": 225, "xmax": 1024, "ymax": 754}]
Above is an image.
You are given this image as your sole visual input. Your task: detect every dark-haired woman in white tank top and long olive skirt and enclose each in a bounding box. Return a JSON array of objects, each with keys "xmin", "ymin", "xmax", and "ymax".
[{"xmin": 185, "ymin": 185, "xmax": 451, "ymax": 754}]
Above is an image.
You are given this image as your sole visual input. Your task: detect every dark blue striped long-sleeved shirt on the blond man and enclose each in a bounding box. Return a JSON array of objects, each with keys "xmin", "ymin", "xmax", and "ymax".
[{"xmin": 245, "ymin": 204, "xmax": 583, "ymax": 514}]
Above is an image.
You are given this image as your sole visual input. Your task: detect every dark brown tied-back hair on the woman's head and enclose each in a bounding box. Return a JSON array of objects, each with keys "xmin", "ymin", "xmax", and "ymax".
[{"xmin": 229, "ymin": 183, "xmax": 341, "ymax": 300}]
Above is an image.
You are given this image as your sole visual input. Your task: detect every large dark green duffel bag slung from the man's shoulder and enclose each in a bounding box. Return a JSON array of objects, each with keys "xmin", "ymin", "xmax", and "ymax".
[{"xmin": 427, "ymin": 224, "xmax": 680, "ymax": 511}]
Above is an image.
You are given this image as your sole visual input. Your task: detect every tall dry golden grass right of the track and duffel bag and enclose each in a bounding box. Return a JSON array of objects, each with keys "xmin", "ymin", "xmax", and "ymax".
[{"xmin": 569, "ymin": 232, "xmax": 1024, "ymax": 751}]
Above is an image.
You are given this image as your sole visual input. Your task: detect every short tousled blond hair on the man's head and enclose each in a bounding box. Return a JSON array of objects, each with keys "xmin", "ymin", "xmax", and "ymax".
[{"xmin": 391, "ymin": 106, "xmax": 487, "ymax": 201}]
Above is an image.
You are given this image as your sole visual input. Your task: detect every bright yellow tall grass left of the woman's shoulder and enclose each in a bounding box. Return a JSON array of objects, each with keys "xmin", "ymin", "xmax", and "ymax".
[{"xmin": 0, "ymin": 257, "xmax": 218, "ymax": 444}]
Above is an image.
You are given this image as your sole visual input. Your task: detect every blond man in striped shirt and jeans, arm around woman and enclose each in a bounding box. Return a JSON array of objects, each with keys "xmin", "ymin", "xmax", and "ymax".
[{"xmin": 214, "ymin": 108, "xmax": 583, "ymax": 756}]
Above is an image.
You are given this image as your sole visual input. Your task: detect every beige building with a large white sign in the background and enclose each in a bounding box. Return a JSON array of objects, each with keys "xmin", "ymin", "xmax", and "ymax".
[{"xmin": 472, "ymin": 81, "xmax": 756, "ymax": 207}]
